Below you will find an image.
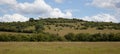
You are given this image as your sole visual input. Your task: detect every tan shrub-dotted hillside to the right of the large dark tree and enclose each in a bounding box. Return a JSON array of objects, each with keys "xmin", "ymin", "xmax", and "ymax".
[{"xmin": 44, "ymin": 19, "xmax": 120, "ymax": 36}]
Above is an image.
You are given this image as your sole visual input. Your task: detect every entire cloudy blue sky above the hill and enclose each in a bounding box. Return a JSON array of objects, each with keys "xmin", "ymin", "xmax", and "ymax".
[{"xmin": 0, "ymin": 0, "xmax": 120, "ymax": 23}]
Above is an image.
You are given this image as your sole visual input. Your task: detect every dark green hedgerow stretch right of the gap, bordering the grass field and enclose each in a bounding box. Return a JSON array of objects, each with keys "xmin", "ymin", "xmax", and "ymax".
[{"xmin": 65, "ymin": 33, "xmax": 120, "ymax": 41}]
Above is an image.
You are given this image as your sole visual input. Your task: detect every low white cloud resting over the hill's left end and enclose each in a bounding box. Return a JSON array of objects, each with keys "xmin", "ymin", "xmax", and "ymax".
[{"xmin": 0, "ymin": 14, "xmax": 29, "ymax": 22}]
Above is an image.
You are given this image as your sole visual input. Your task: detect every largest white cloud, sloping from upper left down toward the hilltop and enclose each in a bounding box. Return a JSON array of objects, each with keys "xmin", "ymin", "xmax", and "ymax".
[{"xmin": 0, "ymin": 0, "xmax": 72, "ymax": 22}]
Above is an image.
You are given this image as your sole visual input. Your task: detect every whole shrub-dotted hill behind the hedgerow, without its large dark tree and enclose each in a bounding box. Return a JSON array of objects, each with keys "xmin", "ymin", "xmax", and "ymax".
[{"xmin": 0, "ymin": 18, "xmax": 120, "ymax": 36}]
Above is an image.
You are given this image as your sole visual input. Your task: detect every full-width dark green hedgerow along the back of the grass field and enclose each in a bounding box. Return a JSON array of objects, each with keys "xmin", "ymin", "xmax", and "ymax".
[{"xmin": 0, "ymin": 33, "xmax": 120, "ymax": 42}]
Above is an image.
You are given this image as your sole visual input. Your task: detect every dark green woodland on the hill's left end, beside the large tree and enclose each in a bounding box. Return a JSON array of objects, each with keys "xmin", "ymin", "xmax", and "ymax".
[{"xmin": 0, "ymin": 22, "xmax": 35, "ymax": 33}]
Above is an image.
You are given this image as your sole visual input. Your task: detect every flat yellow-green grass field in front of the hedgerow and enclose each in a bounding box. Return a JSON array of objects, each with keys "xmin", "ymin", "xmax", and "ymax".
[{"xmin": 0, "ymin": 42, "xmax": 120, "ymax": 54}]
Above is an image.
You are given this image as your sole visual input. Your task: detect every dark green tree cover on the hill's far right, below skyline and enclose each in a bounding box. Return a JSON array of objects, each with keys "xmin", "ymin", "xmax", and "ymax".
[{"xmin": 81, "ymin": 22, "xmax": 120, "ymax": 30}]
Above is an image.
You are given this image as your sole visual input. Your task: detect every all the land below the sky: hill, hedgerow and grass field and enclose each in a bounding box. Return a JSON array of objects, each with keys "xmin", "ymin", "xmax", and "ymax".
[{"xmin": 0, "ymin": 18, "xmax": 120, "ymax": 54}]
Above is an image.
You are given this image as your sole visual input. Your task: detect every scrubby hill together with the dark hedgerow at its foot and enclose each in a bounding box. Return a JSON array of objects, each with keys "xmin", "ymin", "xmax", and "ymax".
[{"xmin": 0, "ymin": 18, "xmax": 120, "ymax": 42}]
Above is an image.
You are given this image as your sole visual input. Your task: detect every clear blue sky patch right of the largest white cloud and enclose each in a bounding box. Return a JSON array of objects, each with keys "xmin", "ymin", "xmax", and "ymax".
[{"xmin": 46, "ymin": 0, "xmax": 110, "ymax": 17}]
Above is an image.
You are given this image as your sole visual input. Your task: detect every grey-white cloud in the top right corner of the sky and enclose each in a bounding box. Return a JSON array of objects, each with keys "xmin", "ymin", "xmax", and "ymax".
[{"xmin": 89, "ymin": 0, "xmax": 120, "ymax": 9}]
